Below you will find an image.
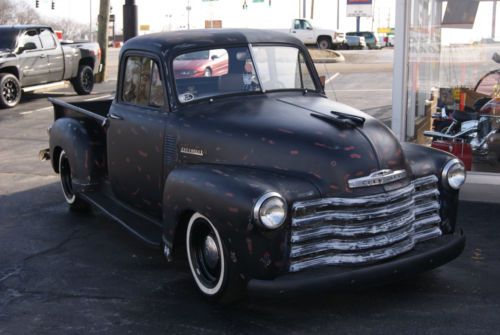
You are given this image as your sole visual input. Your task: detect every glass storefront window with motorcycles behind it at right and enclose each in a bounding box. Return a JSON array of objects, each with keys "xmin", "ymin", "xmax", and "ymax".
[{"xmin": 406, "ymin": 0, "xmax": 500, "ymax": 172}]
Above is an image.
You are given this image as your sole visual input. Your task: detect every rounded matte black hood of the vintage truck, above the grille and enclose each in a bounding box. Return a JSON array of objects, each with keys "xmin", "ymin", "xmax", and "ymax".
[{"xmin": 177, "ymin": 95, "xmax": 410, "ymax": 197}]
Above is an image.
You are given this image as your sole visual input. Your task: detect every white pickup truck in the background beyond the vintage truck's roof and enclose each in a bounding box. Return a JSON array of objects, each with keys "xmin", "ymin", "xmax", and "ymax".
[{"xmin": 273, "ymin": 19, "xmax": 346, "ymax": 49}]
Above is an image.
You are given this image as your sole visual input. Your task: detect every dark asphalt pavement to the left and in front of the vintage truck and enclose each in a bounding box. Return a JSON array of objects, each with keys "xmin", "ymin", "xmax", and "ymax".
[{"xmin": 0, "ymin": 48, "xmax": 500, "ymax": 334}]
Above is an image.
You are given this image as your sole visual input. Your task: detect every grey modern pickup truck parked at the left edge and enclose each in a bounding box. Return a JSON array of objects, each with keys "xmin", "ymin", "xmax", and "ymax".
[{"xmin": 0, "ymin": 25, "xmax": 101, "ymax": 108}]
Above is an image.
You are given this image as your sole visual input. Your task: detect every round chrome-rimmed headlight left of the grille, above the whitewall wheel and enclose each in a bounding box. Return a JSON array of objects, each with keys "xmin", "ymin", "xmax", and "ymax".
[{"xmin": 253, "ymin": 192, "xmax": 286, "ymax": 229}]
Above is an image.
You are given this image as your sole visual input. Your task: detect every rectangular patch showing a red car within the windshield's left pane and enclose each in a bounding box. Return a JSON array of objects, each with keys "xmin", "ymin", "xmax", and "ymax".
[{"xmin": 174, "ymin": 49, "xmax": 228, "ymax": 79}]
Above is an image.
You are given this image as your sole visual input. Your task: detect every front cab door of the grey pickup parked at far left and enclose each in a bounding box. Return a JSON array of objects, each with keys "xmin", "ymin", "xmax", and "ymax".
[{"xmin": 17, "ymin": 29, "xmax": 50, "ymax": 86}]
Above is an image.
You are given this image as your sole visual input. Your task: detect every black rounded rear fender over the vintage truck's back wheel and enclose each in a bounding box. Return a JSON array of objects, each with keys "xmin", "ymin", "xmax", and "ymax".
[{"xmin": 49, "ymin": 118, "xmax": 106, "ymax": 192}]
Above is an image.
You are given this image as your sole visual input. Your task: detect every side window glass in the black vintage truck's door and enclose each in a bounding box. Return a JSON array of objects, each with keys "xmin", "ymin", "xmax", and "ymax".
[{"xmin": 122, "ymin": 56, "xmax": 164, "ymax": 107}]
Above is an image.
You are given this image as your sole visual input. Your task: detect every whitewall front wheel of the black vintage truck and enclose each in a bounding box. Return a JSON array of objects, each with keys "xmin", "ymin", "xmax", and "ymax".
[{"xmin": 186, "ymin": 213, "xmax": 246, "ymax": 303}]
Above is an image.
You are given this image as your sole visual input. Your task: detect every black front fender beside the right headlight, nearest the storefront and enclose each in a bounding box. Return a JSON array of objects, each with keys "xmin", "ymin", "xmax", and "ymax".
[{"xmin": 401, "ymin": 143, "xmax": 459, "ymax": 234}]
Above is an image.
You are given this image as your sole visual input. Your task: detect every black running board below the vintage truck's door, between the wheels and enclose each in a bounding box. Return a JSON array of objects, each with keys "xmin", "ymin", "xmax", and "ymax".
[{"xmin": 79, "ymin": 191, "xmax": 163, "ymax": 248}]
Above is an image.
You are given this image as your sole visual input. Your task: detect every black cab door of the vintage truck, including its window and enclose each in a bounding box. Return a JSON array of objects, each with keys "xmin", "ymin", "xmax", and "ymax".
[{"xmin": 107, "ymin": 54, "xmax": 168, "ymax": 218}]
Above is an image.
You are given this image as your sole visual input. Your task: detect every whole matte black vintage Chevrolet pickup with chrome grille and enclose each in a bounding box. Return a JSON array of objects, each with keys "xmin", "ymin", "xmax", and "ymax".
[{"xmin": 40, "ymin": 29, "xmax": 465, "ymax": 301}]
